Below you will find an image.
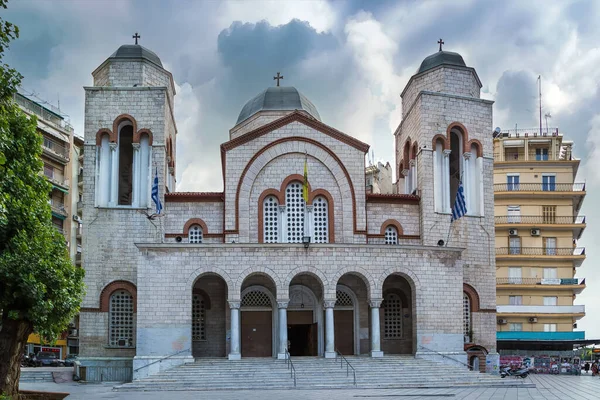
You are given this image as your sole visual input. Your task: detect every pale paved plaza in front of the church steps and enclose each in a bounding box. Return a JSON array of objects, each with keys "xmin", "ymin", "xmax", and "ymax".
[{"xmin": 16, "ymin": 375, "xmax": 600, "ymax": 400}]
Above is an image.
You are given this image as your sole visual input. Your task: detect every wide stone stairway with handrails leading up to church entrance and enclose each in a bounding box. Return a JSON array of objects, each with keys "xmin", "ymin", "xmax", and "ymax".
[{"xmin": 115, "ymin": 356, "xmax": 535, "ymax": 391}]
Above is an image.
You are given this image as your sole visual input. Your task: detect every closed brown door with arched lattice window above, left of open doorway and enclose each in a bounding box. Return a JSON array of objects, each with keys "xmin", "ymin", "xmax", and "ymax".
[{"xmin": 240, "ymin": 285, "xmax": 277, "ymax": 357}]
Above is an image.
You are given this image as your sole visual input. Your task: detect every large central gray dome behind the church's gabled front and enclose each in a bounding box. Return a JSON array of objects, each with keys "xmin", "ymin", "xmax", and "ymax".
[{"xmin": 236, "ymin": 86, "xmax": 321, "ymax": 125}]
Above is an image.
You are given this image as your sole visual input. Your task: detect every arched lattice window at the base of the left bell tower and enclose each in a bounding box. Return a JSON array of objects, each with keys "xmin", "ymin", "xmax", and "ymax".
[{"xmin": 108, "ymin": 289, "xmax": 134, "ymax": 347}]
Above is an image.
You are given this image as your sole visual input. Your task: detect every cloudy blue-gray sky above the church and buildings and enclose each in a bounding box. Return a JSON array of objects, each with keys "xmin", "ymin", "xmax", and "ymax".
[{"xmin": 3, "ymin": 0, "xmax": 600, "ymax": 339}]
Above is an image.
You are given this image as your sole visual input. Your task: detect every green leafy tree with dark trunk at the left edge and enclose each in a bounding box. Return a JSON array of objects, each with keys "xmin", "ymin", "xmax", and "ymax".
[{"xmin": 0, "ymin": 0, "xmax": 84, "ymax": 397}]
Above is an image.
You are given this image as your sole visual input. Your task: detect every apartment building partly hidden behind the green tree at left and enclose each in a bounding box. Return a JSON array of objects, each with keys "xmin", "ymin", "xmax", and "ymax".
[{"xmin": 14, "ymin": 94, "xmax": 83, "ymax": 358}]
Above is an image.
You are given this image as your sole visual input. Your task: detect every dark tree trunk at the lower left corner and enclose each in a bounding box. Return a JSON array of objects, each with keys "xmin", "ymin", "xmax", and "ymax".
[{"xmin": 0, "ymin": 318, "xmax": 33, "ymax": 398}]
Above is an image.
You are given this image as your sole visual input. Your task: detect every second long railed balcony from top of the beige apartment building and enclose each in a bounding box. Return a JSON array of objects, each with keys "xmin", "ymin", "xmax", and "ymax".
[{"xmin": 494, "ymin": 215, "xmax": 586, "ymax": 238}]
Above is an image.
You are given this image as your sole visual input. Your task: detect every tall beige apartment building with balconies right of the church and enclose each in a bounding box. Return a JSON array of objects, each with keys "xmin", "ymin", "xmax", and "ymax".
[{"xmin": 494, "ymin": 129, "xmax": 586, "ymax": 354}]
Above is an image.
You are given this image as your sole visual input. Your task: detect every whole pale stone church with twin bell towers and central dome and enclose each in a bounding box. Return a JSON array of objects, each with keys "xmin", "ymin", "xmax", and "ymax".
[{"xmin": 80, "ymin": 40, "xmax": 496, "ymax": 381}]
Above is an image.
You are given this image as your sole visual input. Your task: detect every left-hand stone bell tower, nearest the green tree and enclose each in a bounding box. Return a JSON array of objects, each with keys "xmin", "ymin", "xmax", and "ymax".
[{"xmin": 80, "ymin": 38, "xmax": 176, "ymax": 379}]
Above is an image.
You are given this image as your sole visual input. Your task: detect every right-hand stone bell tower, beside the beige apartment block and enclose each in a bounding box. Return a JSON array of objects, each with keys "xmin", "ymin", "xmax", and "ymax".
[{"xmin": 395, "ymin": 43, "xmax": 496, "ymax": 350}]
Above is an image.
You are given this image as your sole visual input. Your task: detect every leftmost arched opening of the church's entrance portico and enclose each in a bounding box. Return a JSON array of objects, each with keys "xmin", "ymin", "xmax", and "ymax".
[{"xmin": 190, "ymin": 273, "xmax": 229, "ymax": 358}]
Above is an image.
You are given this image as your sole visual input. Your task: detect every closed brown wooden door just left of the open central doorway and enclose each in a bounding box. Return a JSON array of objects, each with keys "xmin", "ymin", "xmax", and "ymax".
[{"xmin": 241, "ymin": 311, "xmax": 273, "ymax": 357}]
